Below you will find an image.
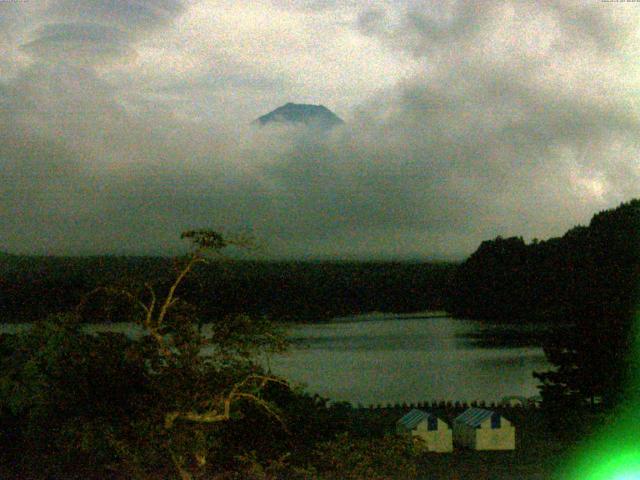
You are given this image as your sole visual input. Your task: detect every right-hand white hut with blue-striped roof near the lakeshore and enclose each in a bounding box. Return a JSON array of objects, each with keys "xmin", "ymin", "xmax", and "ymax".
[{"xmin": 453, "ymin": 408, "xmax": 516, "ymax": 450}]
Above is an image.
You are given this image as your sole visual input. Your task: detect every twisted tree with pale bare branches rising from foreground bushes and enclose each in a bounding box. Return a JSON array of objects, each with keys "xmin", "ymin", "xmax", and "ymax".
[{"xmin": 77, "ymin": 230, "xmax": 288, "ymax": 480}]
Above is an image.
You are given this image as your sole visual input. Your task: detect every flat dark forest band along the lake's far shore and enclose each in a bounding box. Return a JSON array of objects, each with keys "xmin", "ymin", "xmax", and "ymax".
[{"xmin": 0, "ymin": 254, "xmax": 455, "ymax": 322}]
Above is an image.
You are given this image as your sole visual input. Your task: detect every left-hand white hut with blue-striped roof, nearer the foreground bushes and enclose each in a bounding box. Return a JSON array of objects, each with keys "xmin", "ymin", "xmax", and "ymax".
[{"xmin": 396, "ymin": 408, "xmax": 453, "ymax": 452}]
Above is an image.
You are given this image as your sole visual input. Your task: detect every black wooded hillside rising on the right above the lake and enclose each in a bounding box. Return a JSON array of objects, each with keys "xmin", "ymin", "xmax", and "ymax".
[{"xmin": 447, "ymin": 199, "xmax": 640, "ymax": 321}]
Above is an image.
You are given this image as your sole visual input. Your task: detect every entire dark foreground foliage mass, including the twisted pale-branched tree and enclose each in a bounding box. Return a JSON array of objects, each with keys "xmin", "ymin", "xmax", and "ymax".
[{"xmin": 0, "ymin": 232, "xmax": 428, "ymax": 480}]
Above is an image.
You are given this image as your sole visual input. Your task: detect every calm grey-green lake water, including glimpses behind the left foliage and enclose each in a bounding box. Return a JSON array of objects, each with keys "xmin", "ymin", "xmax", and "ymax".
[{"xmin": 0, "ymin": 314, "xmax": 549, "ymax": 405}]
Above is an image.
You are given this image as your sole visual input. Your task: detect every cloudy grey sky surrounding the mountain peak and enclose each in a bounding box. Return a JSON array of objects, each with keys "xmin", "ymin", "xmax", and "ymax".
[{"xmin": 0, "ymin": 0, "xmax": 640, "ymax": 260}]
